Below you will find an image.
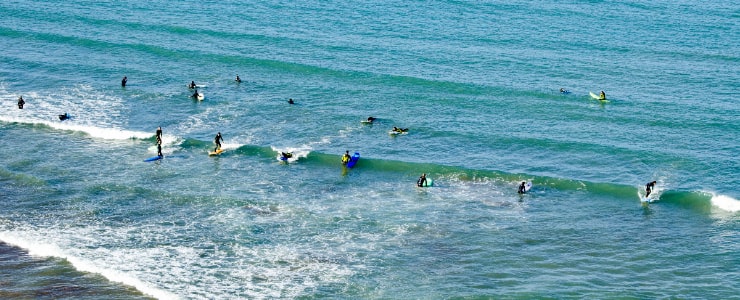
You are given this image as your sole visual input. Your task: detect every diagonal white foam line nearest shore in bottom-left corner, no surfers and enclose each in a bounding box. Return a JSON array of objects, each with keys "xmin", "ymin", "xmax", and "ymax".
[{"xmin": 0, "ymin": 232, "xmax": 178, "ymax": 299}]
